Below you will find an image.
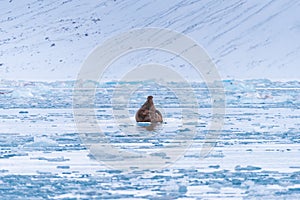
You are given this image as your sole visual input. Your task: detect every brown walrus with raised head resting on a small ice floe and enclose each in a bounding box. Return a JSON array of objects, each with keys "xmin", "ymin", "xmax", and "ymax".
[{"xmin": 135, "ymin": 96, "xmax": 163, "ymax": 122}]
